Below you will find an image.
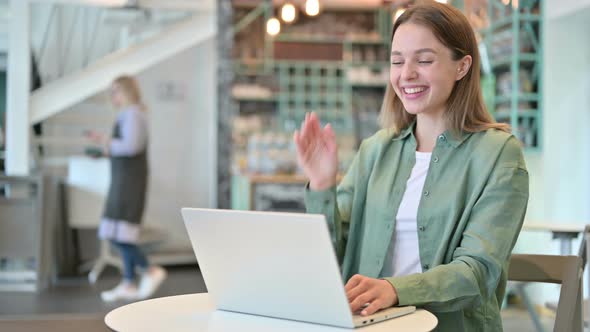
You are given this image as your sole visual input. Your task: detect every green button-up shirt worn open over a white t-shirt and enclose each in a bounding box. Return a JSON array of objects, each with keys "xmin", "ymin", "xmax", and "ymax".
[{"xmin": 305, "ymin": 126, "xmax": 529, "ymax": 332}]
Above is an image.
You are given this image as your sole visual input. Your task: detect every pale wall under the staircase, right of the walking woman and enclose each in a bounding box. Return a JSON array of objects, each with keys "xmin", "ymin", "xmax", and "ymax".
[{"xmin": 138, "ymin": 39, "xmax": 217, "ymax": 250}]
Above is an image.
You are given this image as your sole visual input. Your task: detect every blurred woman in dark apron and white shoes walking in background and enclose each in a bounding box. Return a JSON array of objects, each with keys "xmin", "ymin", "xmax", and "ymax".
[{"xmin": 91, "ymin": 76, "xmax": 166, "ymax": 302}]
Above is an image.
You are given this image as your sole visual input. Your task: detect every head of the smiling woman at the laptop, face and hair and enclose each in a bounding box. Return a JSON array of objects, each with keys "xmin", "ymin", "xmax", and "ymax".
[{"xmin": 380, "ymin": 1, "xmax": 509, "ymax": 144}]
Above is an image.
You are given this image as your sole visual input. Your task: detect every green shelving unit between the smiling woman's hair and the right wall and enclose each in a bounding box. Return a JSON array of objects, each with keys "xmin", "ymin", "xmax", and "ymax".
[{"xmin": 481, "ymin": 0, "xmax": 544, "ymax": 151}]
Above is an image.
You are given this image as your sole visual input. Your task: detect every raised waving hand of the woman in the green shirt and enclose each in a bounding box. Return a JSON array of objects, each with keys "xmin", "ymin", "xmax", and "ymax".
[{"xmin": 293, "ymin": 113, "xmax": 338, "ymax": 190}]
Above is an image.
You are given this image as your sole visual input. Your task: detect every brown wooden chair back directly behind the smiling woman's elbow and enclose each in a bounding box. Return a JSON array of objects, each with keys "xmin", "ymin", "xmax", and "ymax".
[{"xmin": 508, "ymin": 254, "xmax": 586, "ymax": 332}]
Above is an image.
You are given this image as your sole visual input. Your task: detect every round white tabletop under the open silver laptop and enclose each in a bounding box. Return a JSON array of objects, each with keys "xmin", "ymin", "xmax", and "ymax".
[{"xmin": 104, "ymin": 293, "xmax": 438, "ymax": 332}]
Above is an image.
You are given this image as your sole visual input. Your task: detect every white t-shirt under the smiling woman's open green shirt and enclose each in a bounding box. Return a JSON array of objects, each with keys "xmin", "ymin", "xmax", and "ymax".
[{"xmin": 381, "ymin": 151, "xmax": 432, "ymax": 277}]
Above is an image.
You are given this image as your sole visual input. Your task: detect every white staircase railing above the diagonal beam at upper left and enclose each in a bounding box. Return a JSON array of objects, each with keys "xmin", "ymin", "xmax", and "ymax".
[{"xmin": 32, "ymin": 0, "xmax": 197, "ymax": 83}]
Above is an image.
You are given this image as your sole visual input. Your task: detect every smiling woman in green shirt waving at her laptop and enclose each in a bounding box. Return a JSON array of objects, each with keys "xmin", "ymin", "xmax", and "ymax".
[{"xmin": 294, "ymin": 1, "xmax": 528, "ymax": 331}]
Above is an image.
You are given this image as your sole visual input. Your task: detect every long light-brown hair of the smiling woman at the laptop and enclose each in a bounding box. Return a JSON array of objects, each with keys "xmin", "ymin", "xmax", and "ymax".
[{"xmin": 379, "ymin": 1, "xmax": 510, "ymax": 134}]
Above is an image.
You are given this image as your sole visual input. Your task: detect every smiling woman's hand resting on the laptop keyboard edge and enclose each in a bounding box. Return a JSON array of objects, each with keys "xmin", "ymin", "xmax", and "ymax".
[{"xmin": 344, "ymin": 274, "xmax": 398, "ymax": 316}]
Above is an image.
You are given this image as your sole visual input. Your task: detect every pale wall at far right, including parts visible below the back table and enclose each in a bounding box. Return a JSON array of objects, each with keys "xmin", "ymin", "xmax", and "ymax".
[{"xmin": 516, "ymin": 0, "xmax": 590, "ymax": 305}]
